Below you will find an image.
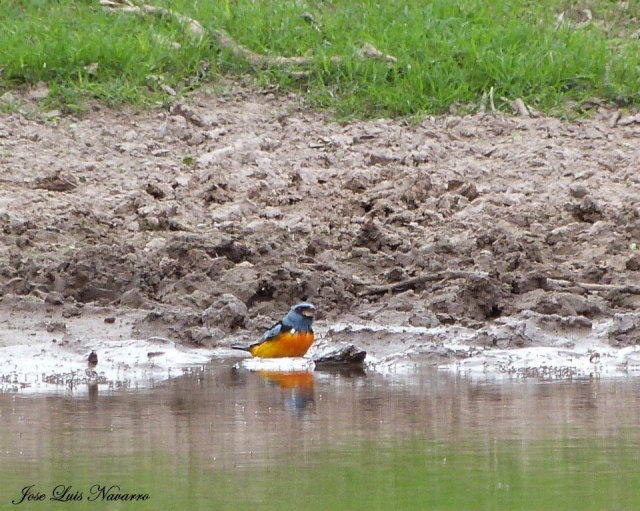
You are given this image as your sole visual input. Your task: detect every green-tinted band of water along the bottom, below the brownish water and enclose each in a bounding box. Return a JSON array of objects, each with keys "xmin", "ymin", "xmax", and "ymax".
[{"xmin": 0, "ymin": 439, "xmax": 640, "ymax": 511}]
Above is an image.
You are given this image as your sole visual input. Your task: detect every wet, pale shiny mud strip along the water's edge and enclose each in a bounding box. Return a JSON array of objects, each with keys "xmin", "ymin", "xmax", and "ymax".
[{"xmin": 0, "ymin": 296, "xmax": 640, "ymax": 396}]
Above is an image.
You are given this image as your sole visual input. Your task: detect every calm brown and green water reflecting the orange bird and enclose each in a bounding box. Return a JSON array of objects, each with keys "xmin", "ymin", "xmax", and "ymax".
[{"xmin": 0, "ymin": 361, "xmax": 640, "ymax": 511}]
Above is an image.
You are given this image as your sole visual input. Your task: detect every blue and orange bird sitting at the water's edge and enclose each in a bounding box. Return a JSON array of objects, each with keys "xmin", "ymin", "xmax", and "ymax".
[{"xmin": 231, "ymin": 302, "xmax": 316, "ymax": 358}]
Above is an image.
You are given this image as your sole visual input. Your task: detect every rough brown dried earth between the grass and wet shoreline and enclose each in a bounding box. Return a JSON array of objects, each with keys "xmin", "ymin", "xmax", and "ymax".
[{"xmin": 0, "ymin": 88, "xmax": 640, "ymax": 356}]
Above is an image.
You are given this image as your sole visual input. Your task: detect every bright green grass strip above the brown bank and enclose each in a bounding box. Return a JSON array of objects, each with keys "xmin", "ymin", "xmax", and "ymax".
[{"xmin": 0, "ymin": 0, "xmax": 640, "ymax": 117}]
